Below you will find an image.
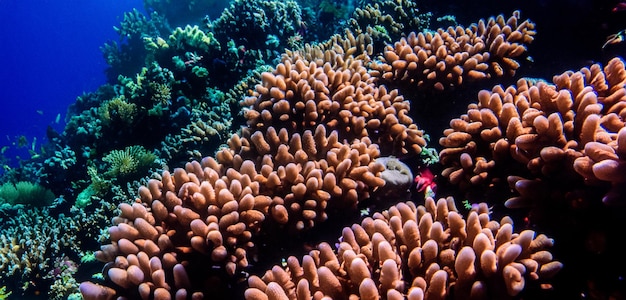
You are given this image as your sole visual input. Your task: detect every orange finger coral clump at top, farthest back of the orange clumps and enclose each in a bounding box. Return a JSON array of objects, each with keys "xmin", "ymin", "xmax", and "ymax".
[{"xmin": 371, "ymin": 11, "xmax": 535, "ymax": 90}]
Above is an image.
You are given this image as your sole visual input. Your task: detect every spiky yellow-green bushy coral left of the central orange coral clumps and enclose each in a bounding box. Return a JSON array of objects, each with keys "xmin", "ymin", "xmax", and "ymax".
[{"xmin": 102, "ymin": 145, "xmax": 157, "ymax": 178}]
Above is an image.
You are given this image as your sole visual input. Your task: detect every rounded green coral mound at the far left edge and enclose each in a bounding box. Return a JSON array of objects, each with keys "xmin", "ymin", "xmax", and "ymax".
[{"xmin": 0, "ymin": 181, "xmax": 56, "ymax": 206}]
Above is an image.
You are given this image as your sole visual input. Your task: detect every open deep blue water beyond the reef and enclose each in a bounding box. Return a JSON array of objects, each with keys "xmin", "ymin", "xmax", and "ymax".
[{"xmin": 0, "ymin": 0, "xmax": 143, "ymax": 163}]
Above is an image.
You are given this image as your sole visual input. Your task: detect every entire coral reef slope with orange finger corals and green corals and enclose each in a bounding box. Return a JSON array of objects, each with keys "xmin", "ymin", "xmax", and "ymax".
[{"xmin": 0, "ymin": 0, "xmax": 626, "ymax": 300}]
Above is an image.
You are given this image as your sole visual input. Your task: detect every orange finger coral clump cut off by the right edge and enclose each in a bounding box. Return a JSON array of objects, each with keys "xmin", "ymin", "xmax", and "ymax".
[{"xmin": 440, "ymin": 58, "xmax": 626, "ymax": 207}]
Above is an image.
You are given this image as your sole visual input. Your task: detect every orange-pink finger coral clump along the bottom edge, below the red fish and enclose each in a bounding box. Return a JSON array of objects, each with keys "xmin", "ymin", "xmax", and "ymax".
[{"xmin": 245, "ymin": 198, "xmax": 562, "ymax": 300}]
